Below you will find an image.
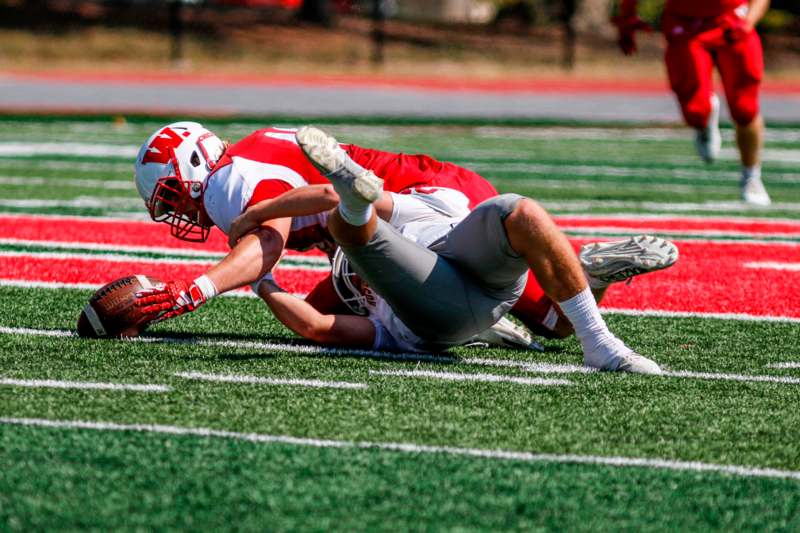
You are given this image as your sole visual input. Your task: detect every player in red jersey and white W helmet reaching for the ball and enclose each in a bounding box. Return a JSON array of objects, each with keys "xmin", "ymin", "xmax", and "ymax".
[{"xmin": 136, "ymin": 122, "xmax": 676, "ymax": 356}]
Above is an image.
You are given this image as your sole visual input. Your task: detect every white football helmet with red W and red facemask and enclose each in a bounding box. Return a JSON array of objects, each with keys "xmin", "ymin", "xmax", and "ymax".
[{"xmin": 136, "ymin": 122, "xmax": 225, "ymax": 242}]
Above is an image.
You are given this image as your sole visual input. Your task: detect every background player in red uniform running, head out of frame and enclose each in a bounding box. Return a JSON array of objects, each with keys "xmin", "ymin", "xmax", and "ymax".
[{"xmin": 613, "ymin": 0, "xmax": 771, "ymax": 206}]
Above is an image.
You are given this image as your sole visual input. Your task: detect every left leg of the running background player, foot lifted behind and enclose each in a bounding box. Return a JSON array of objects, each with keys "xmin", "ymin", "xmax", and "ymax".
[{"xmin": 665, "ymin": 27, "xmax": 722, "ymax": 163}]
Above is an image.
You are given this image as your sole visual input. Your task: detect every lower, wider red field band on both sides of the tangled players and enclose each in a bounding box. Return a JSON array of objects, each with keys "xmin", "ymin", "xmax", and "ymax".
[{"xmin": 0, "ymin": 241, "xmax": 800, "ymax": 318}]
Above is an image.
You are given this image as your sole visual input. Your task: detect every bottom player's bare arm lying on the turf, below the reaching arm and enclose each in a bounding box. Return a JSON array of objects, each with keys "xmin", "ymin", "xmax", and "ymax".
[{"xmin": 258, "ymin": 274, "xmax": 375, "ymax": 348}]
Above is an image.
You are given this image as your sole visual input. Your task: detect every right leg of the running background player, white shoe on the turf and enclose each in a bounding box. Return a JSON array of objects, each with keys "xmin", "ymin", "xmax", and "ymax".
[{"xmin": 717, "ymin": 31, "xmax": 771, "ymax": 206}]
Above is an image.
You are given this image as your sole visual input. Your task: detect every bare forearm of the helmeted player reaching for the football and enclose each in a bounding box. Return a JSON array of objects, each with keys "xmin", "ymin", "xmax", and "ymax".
[{"xmin": 206, "ymin": 218, "xmax": 291, "ymax": 293}]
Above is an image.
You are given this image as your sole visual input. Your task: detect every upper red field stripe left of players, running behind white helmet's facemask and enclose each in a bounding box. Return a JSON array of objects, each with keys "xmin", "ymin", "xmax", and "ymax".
[{"xmin": 0, "ymin": 215, "xmax": 320, "ymax": 255}]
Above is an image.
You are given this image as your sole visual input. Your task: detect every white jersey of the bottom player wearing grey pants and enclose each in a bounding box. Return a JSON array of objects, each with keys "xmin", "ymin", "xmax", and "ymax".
[{"xmin": 366, "ymin": 189, "xmax": 469, "ymax": 351}]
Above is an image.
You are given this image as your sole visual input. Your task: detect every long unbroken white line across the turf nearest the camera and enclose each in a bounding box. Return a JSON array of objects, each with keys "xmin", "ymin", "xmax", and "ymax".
[{"xmin": 0, "ymin": 417, "xmax": 800, "ymax": 481}]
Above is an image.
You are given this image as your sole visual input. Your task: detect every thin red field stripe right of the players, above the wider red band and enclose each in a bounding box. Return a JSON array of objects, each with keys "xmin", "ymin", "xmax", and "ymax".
[{"xmin": 554, "ymin": 216, "xmax": 800, "ymax": 236}]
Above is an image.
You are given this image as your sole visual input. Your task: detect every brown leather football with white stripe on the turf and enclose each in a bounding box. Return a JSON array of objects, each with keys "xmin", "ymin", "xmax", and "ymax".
[{"xmin": 78, "ymin": 274, "xmax": 161, "ymax": 338}]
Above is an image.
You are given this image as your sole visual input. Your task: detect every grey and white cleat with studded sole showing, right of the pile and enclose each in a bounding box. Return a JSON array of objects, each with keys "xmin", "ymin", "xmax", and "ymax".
[{"xmin": 578, "ymin": 235, "xmax": 678, "ymax": 283}]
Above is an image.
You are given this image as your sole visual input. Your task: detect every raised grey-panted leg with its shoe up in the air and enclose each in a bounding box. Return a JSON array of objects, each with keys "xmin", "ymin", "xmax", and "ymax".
[{"xmin": 297, "ymin": 124, "xmax": 510, "ymax": 349}]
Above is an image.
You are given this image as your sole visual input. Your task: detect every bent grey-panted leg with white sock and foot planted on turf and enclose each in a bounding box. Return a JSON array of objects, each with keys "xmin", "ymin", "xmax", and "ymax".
[{"xmin": 431, "ymin": 194, "xmax": 660, "ymax": 373}]
